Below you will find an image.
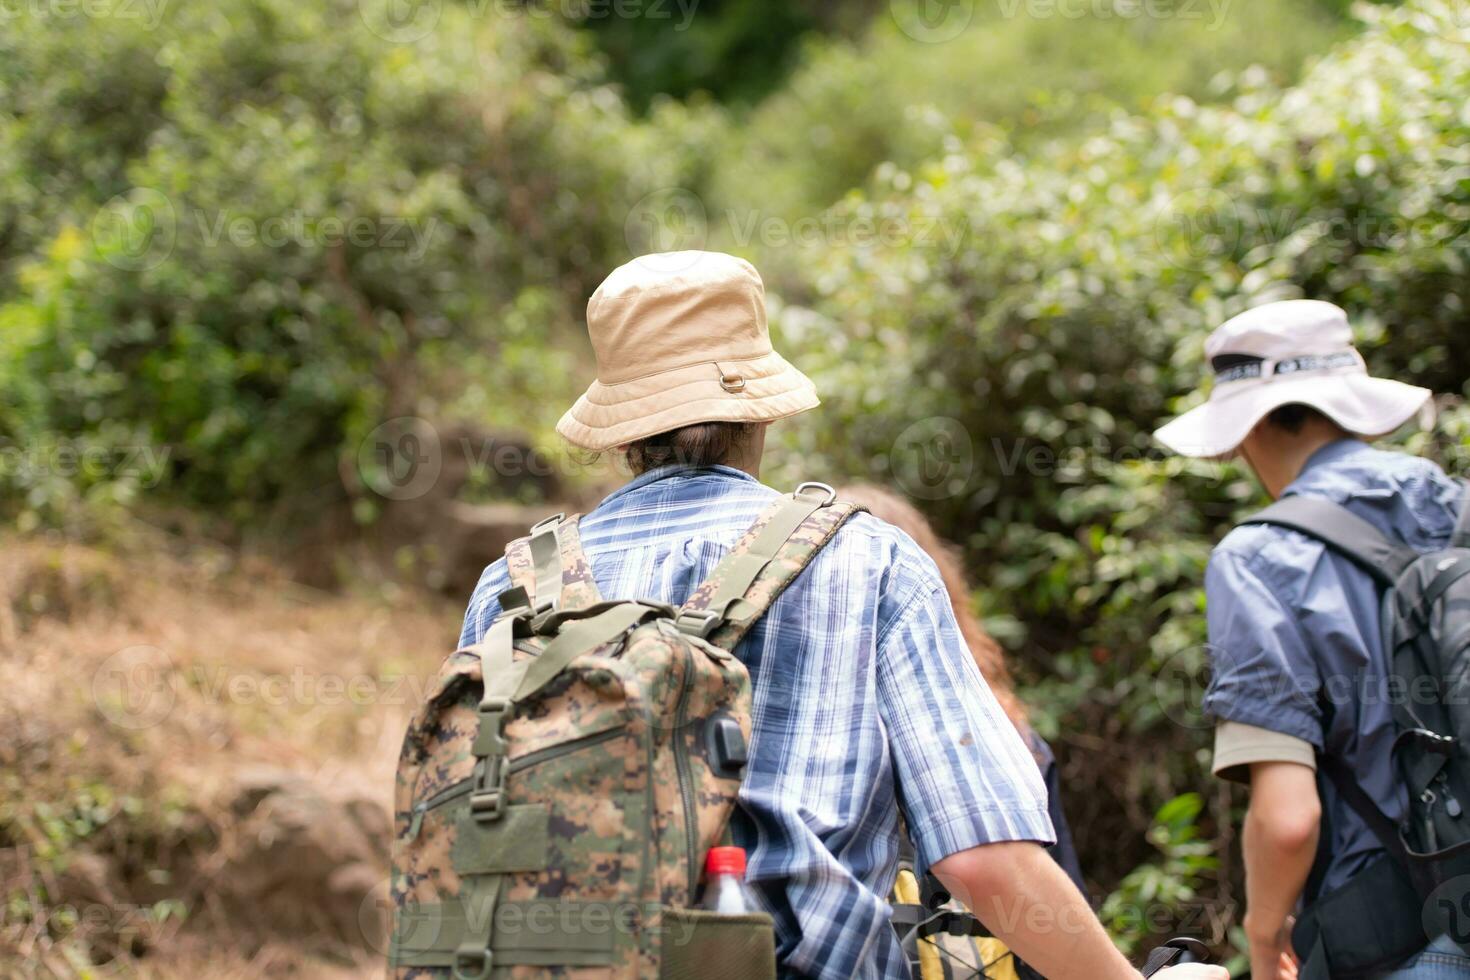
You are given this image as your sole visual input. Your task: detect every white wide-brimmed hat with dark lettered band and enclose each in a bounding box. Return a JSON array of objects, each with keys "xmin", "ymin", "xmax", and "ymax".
[{"xmin": 1154, "ymin": 300, "xmax": 1433, "ymax": 458}]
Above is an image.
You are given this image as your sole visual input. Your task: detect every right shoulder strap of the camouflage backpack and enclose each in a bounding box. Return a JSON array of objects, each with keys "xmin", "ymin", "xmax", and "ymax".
[{"xmin": 676, "ymin": 483, "xmax": 864, "ymax": 649}]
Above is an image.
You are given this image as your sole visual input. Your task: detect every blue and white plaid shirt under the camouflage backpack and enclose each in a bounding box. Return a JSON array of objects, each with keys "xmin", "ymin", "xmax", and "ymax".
[{"xmin": 462, "ymin": 467, "xmax": 1054, "ymax": 980}]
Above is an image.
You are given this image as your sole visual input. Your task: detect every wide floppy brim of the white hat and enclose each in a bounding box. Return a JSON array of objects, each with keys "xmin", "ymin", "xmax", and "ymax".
[{"xmin": 1154, "ymin": 375, "xmax": 1433, "ymax": 458}]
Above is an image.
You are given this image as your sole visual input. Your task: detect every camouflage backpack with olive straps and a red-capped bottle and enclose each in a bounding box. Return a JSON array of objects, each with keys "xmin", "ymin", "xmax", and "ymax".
[{"xmin": 390, "ymin": 483, "xmax": 858, "ymax": 980}]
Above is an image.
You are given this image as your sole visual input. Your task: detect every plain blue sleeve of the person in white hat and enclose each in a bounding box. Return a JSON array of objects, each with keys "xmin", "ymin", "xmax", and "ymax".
[{"xmin": 1204, "ymin": 552, "xmax": 1323, "ymax": 749}]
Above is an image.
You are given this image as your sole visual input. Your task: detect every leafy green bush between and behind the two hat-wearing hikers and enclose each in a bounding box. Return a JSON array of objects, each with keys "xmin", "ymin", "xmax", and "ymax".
[{"xmin": 776, "ymin": 0, "xmax": 1470, "ymax": 934}]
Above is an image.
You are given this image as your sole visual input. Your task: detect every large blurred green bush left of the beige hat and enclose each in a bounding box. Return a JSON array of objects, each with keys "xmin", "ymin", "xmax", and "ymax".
[{"xmin": 0, "ymin": 0, "xmax": 711, "ymax": 528}]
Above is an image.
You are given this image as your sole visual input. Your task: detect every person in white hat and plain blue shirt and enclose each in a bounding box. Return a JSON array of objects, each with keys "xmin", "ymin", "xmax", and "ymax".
[{"xmin": 1155, "ymin": 300, "xmax": 1470, "ymax": 980}]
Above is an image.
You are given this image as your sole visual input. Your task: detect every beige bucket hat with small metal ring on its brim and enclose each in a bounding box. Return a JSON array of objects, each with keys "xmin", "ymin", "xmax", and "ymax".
[{"xmin": 556, "ymin": 251, "xmax": 819, "ymax": 451}]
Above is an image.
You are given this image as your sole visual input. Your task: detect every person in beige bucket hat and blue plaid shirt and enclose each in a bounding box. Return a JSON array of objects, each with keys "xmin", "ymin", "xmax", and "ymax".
[{"xmin": 449, "ymin": 251, "xmax": 1226, "ymax": 980}]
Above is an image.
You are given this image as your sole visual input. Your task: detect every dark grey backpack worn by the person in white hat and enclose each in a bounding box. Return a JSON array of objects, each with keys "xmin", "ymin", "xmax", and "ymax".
[{"xmin": 1244, "ymin": 486, "xmax": 1470, "ymax": 980}]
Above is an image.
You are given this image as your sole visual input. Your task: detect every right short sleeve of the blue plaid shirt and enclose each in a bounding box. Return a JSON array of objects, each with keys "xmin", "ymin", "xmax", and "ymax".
[{"xmin": 878, "ymin": 586, "xmax": 1055, "ymax": 876}]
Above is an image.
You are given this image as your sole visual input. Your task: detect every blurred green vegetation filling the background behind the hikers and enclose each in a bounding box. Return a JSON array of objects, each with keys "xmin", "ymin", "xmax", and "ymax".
[{"xmin": 0, "ymin": 0, "xmax": 1470, "ymax": 975}]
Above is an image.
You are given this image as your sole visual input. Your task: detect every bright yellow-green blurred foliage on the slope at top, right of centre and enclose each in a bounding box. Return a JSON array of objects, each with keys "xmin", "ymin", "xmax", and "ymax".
[{"xmin": 711, "ymin": 0, "xmax": 1347, "ymax": 238}]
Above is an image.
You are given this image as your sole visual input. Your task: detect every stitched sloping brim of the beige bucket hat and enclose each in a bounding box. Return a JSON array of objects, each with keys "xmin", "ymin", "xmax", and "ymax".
[{"xmin": 556, "ymin": 351, "xmax": 822, "ymax": 453}]
